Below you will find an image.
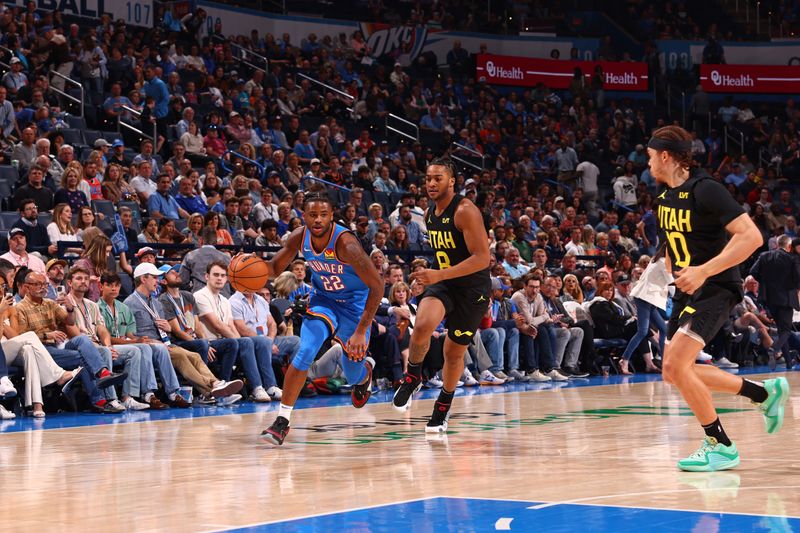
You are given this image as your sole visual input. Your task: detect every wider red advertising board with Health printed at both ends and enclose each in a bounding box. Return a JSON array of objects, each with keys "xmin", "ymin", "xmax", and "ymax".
[{"xmin": 477, "ymin": 54, "xmax": 647, "ymax": 91}]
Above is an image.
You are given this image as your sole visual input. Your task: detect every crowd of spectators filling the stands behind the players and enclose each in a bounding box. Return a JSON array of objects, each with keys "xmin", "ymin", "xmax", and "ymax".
[{"xmin": 0, "ymin": 6, "xmax": 800, "ymax": 416}]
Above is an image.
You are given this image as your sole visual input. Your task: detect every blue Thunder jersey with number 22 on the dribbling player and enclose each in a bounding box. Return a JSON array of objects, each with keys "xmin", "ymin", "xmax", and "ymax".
[{"xmin": 303, "ymin": 224, "xmax": 369, "ymax": 310}]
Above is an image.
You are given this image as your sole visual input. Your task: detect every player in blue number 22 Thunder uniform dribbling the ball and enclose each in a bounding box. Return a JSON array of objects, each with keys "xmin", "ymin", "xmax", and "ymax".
[{"xmin": 261, "ymin": 190, "xmax": 383, "ymax": 445}]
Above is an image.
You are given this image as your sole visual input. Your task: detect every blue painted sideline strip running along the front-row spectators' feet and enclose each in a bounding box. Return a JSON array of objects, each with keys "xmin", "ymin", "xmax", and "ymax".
[{"xmin": 0, "ymin": 367, "xmax": 780, "ymax": 434}]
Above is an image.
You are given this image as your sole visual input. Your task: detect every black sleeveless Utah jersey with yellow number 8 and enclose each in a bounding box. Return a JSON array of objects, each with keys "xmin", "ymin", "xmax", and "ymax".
[{"xmin": 425, "ymin": 194, "xmax": 491, "ymax": 288}]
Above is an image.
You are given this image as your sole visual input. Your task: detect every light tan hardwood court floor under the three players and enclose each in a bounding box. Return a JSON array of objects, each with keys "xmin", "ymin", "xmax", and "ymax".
[{"xmin": 0, "ymin": 373, "xmax": 800, "ymax": 531}]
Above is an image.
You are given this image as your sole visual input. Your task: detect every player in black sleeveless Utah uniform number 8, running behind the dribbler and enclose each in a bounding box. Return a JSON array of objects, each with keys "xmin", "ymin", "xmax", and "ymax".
[{"xmin": 393, "ymin": 159, "xmax": 492, "ymax": 433}]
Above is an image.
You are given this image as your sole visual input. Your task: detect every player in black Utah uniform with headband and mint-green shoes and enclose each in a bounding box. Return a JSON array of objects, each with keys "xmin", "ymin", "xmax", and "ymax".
[{"xmin": 647, "ymin": 126, "xmax": 789, "ymax": 472}]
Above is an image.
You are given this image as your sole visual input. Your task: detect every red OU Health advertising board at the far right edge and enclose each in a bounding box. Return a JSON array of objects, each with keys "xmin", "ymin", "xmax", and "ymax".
[{"xmin": 700, "ymin": 65, "xmax": 800, "ymax": 93}]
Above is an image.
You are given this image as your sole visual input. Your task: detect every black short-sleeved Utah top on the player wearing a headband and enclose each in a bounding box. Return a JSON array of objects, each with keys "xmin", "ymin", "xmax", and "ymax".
[{"xmin": 656, "ymin": 170, "xmax": 744, "ymax": 283}]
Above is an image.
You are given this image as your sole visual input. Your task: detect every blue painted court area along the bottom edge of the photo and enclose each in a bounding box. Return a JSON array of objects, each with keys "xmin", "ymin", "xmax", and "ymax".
[{"xmin": 220, "ymin": 498, "xmax": 800, "ymax": 533}]
